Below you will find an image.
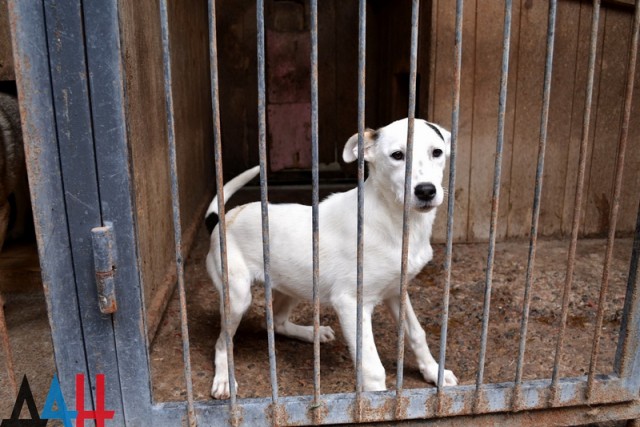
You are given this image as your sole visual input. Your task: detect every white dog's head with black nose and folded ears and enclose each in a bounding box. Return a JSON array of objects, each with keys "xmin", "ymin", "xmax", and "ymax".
[{"xmin": 342, "ymin": 119, "xmax": 451, "ymax": 212}]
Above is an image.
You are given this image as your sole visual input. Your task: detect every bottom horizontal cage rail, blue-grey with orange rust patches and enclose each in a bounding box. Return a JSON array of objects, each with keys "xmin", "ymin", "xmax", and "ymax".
[{"xmin": 150, "ymin": 377, "xmax": 640, "ymax": 427}]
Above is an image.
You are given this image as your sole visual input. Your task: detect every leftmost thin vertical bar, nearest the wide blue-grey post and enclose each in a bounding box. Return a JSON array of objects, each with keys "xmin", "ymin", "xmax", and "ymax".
[{"xmin": 160, "ymin": 0, "xmax": 197, "ymax": 426}]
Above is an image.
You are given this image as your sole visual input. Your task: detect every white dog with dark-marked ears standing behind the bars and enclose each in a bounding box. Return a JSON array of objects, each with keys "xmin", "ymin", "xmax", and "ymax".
[{"xmin": 207, "ymin": 119, "xmax": 458, "ymax": 399}]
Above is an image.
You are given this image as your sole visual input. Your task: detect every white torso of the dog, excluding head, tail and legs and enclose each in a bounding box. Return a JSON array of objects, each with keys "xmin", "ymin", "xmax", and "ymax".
[{"xmin": 207, "ymin": 189, "xmax": 435, "ymax": 303}]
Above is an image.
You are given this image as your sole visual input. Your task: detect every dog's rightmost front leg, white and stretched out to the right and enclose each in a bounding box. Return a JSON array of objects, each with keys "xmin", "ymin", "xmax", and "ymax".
[{"xmin": 385, "ymin": 296, "xmax": 458, "ymax": 385}]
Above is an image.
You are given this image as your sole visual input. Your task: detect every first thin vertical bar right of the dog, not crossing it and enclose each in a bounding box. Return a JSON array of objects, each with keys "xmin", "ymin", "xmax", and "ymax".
[{"xmin": 474, "ymin": 0, "xmax": 512, "ymax": 409}]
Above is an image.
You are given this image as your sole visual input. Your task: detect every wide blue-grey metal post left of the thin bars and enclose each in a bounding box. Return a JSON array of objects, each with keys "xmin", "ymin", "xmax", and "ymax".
[{"xmin": 9, "ymin": 0, "xmax": 152, "ymax": 425}]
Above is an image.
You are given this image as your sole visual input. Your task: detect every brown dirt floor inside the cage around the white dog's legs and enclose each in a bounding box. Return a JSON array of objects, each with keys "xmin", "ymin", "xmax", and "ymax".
[{"xmin": 151, "ymin": 229, "xmax": 632, "ymax": 401}]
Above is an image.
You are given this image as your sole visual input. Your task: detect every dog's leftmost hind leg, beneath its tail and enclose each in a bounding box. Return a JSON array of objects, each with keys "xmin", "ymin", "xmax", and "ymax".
[{"xmin": 211, "ymin": 271, "xmax": 251, "ymax": 399}]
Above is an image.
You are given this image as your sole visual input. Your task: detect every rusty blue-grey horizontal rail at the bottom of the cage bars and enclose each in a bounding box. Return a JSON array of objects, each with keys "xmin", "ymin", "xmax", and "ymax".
[{"xmin": 151, "ymin": 377, "xmax": 637, "ymax": 426}]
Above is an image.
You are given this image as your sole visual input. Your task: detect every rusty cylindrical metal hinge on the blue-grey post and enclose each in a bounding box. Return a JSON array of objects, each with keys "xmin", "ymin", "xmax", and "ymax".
[{"xmin": 91, "ymin": 222, "xmax": 118, "ymax": 314}]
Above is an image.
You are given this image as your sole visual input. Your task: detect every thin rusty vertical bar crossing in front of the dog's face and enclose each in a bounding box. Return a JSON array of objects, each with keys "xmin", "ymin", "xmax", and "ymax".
[{"xmin": 396, "ymin": 0, "xmax": 420, "ymax": 402}]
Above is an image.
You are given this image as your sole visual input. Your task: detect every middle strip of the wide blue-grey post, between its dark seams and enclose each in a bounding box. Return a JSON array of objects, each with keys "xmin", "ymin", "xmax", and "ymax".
[{"xmin": 43, "ymin": 0, "xmax": 124, "ymax": 423}]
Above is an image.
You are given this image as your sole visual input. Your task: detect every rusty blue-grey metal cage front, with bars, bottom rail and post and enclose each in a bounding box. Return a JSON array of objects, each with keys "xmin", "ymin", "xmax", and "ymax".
[{"xmin": 9, "ymin": 0, "xmax": 640, "ymax": 426}]
